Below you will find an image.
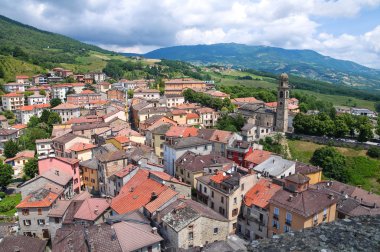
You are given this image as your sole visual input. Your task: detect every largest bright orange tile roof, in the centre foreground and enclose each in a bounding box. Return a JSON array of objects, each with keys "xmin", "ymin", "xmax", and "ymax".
[{"xmin": 111, "ymin": 169, "xmax": 168, "ymax": 214}]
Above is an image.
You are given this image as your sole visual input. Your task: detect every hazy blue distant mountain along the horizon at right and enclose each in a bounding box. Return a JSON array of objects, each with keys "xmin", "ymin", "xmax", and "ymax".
[{"xmin": 143, "ymin": 43, "xmax": 380, "ymax": 89}]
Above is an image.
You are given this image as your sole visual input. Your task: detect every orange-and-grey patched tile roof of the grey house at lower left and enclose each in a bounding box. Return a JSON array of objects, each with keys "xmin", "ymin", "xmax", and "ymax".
[{"xmin": 16, "ymin": 188, "xmax": 59, "ymax": 208}]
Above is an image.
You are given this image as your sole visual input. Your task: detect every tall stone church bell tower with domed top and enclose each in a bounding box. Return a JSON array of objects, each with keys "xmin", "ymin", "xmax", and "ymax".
[{"xmin": 276, "ymin": 73, "xmax": 289, "ymax": 132}]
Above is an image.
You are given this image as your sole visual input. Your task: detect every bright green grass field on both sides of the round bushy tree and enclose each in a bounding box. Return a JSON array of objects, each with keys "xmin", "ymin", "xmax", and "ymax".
[{"xmin": 288, "ymin": 140, "xmax": 380, "ymax": 194}]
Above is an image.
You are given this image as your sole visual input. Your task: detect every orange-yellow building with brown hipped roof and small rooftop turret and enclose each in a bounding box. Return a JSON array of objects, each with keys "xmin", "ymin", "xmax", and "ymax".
[{"xmin": 268, "ymin": 174, "xmax": 338, "ymax": 237}]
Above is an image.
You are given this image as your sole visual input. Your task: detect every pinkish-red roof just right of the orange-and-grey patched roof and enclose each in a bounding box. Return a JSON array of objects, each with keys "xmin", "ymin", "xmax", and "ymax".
[{"xmin": 74, "ymin": 198, "xmax": 110, "ymax": 221}]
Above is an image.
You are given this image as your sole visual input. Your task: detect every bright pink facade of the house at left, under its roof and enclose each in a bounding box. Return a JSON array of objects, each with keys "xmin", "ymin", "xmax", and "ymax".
[{"xmin": 38, "ymin": 157, "xmax": 81, "ymax": 193}]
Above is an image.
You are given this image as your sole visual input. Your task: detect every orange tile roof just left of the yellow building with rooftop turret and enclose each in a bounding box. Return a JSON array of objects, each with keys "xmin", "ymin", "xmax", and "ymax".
[{"xmin": 244, "ymin": 178, "xmax": 282, "ymax": 209}]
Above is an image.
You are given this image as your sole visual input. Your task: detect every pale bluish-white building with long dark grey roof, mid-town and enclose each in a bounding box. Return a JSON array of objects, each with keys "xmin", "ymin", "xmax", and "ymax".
[{"xmin": 164, "ymin": 137, "xmax": 212, "ymax": 176}]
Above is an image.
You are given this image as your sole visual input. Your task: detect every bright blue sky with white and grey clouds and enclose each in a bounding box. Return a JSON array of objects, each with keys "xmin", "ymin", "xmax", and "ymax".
[{"xmin": 0, "ymin": 0, "xmax": 380, "ymax": 69}]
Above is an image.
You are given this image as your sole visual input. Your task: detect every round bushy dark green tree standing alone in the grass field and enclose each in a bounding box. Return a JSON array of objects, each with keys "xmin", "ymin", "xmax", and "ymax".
[{"xmin": 310, "ymin": 146, "xmax": 350, "ymax": 183}]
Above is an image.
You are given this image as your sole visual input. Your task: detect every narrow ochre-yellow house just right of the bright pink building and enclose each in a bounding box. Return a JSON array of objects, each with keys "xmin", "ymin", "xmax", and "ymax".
[{"xmin": 79, "ymin": 159, "xmax": 99, "ymax": 193}]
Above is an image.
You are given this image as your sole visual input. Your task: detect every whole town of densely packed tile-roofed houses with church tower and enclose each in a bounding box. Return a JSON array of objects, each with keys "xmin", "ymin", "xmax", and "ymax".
[{"xmin": 0, "ymin": 68, "xmax": 380, "ymax": 252}]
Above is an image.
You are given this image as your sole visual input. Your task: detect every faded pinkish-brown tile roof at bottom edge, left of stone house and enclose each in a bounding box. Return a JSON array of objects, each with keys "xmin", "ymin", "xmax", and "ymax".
[{"xmin": 113, "ymin": 221, "xmax": 163, "ymax": 252}]
